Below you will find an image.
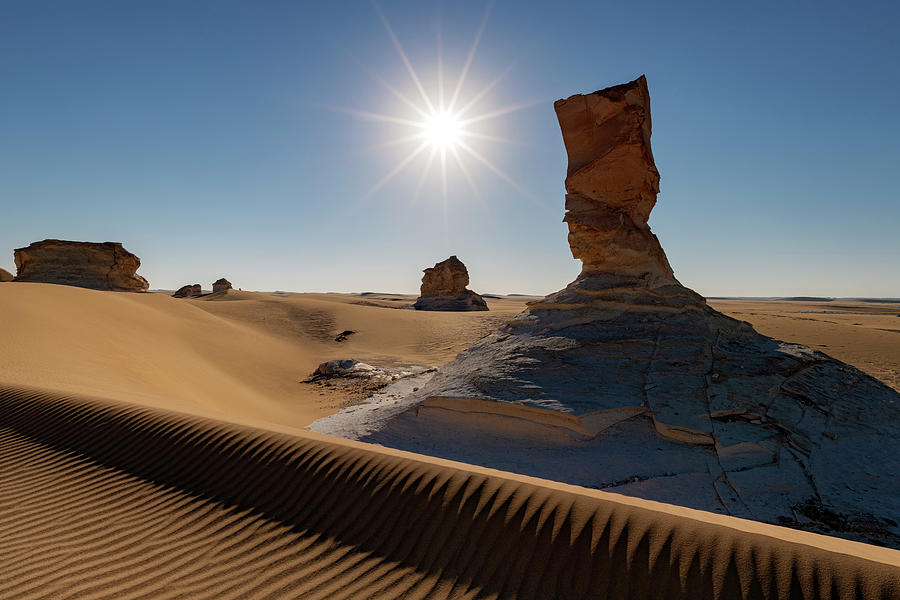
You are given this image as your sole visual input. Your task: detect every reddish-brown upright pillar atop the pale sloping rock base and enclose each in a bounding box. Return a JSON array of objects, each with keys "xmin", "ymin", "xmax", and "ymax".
[{"xmin": 554, "ymin": 76, "xmax": 684, "ymax": 301}]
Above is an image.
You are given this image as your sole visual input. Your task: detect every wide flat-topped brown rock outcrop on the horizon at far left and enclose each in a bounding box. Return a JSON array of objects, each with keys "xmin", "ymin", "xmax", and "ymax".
[{"xmin": 15, "ymin": 240, "xmax": 150, "ymax": 292}]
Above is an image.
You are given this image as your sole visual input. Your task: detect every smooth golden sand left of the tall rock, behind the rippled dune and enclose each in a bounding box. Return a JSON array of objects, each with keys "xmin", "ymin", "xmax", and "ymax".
[{"xmin": 0, "ymin": 283, "xmax": 536, "ymax": 427}]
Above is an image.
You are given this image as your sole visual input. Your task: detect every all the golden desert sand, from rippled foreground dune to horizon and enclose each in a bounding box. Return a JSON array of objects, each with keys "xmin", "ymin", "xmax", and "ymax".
[{"xmin": 0, "ymin": 283, "xmax": 900, "ymax": 599}]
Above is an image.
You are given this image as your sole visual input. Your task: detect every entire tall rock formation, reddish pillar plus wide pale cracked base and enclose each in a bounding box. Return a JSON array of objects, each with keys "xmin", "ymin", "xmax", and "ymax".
[{"xmin": 312, "ymin": 77, "xmax": 900, "ymax": 547}]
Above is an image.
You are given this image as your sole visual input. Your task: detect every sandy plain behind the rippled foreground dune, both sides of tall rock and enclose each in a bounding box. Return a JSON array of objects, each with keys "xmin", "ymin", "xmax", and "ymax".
[{"xmin": 0, "ymin": 283, "xmax": 900, "ymax": 430}]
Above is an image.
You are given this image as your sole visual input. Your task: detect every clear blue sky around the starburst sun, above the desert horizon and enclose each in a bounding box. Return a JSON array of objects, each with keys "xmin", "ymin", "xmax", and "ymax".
[{"xmin": 0, "ymin": 0, "xmax": 900, "ymax": 297}]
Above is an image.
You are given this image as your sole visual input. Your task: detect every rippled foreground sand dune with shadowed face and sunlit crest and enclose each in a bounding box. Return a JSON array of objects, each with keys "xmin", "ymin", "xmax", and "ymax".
[{"xmin": 0, "ymin": 386, "xmax": 900, "ymax": 600}]
